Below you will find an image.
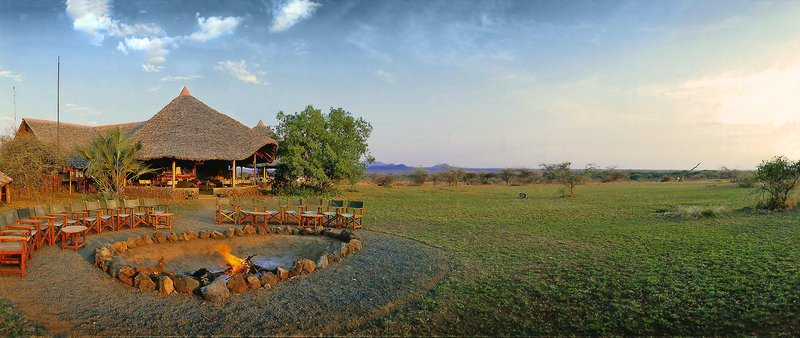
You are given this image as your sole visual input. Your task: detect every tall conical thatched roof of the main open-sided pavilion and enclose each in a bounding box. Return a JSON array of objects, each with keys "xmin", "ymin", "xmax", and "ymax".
[{"xmin": 131, "ymin": 87, "xmax": 278, "ymax": 162}]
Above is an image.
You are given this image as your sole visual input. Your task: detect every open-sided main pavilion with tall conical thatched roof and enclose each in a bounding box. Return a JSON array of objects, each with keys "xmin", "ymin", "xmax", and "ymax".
[{"xmin": 131, "ymin": 87, "xmax": 278, "ymax": 187}]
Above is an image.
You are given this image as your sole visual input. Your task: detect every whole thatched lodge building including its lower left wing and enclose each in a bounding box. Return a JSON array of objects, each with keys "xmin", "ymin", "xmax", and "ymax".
[{"xmin": 17, "ymin": 87, "xmax": 278, "ymax": 193}]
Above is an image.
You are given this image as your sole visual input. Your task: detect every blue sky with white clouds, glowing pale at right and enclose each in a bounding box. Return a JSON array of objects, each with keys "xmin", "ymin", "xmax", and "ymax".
[{"xmin": 0, "ymin": 0, "xmax": 800, "ymax": 169}]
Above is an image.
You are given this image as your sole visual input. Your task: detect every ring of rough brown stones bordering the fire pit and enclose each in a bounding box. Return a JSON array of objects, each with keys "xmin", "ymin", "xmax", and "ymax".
[{"xmin": 94, "ymin": 225, "xmax": 362, "ymax": 302}]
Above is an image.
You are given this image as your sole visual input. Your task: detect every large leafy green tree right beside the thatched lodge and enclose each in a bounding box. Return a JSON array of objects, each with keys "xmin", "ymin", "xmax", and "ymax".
[{"xmin": 276, "ymin": 106, "xmax": 375, "ymax": 190}]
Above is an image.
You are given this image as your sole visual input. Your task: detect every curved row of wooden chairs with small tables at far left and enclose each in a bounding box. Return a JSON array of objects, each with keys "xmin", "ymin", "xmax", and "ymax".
[{"xmin": 0, "ymin": 199, "xmax": 173, "ymax": 277}]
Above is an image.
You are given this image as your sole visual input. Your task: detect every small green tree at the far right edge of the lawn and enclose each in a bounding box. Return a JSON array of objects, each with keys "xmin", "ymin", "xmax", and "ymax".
[{"xmin": 755, "ymin": 156, "xmax": 800, "ymax": 209}]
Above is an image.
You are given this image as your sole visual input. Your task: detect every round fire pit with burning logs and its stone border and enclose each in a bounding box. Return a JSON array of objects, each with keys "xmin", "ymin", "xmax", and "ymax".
[{"xmin": 95, "ymin": 225, "xmax": 362, "ymax": 301}]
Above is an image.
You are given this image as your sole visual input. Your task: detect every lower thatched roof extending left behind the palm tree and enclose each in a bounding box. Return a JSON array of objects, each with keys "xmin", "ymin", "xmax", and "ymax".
[{"xmin": 17, "ymin": 118, "xmax": 144, "ymax": 153}]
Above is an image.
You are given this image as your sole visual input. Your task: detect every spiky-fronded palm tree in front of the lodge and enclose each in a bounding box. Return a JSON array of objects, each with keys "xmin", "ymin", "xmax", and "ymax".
[{"xmin": 77, "ymin": 128, "xmax": 153, "ymax": 196}]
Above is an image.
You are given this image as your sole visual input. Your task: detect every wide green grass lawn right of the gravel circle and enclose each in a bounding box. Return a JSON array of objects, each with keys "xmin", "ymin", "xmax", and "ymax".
[{"xmin": 345, "ymin": 182, "xmax": 800, "ymax": 335}]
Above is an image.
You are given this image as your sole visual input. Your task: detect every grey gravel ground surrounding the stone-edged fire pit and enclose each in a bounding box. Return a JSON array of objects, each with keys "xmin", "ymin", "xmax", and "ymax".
[{"xmin": 0, "ymin": 210, "xmax": 449, "ymax": 336}]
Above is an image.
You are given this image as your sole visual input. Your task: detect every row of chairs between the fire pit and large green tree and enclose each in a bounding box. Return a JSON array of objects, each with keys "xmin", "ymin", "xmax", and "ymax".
[{"xmin": 216, "ymin": 197, "xmax": 364, "ymax": 229}]
